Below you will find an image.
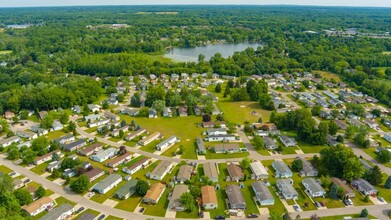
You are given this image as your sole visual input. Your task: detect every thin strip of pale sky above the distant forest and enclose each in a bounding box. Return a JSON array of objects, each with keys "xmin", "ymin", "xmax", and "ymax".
[{"xmin": 0, "ymin": 0, "xmax": 391, "ymax": 7}]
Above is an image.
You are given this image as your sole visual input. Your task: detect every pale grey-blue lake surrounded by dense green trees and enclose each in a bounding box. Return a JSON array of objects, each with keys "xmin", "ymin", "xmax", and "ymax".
[{"xmin": 164, "ymin": 43, "xmax": 262, "ymax": 62}]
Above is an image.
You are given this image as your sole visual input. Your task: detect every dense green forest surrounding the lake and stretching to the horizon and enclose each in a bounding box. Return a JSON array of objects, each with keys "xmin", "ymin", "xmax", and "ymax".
[{"xmin": 0, "ymin": 6, "xmax": 391, "ymax": 113}]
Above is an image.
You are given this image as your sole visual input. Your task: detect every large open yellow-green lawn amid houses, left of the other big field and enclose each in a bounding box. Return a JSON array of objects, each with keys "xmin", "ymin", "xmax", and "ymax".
[{"xmin": 121, "ymin": 115, "xmax": 205, "ymax": 159}]
